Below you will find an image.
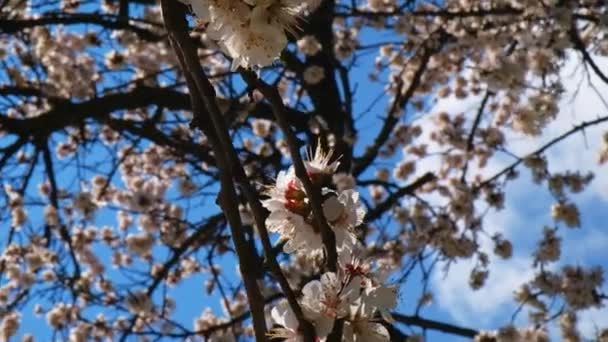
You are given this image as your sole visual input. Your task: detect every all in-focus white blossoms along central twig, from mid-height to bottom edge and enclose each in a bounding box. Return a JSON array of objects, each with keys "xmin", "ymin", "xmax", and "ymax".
[{"xmin": 263, "ymin": 148, "xmax": 397, "ymax": 341}]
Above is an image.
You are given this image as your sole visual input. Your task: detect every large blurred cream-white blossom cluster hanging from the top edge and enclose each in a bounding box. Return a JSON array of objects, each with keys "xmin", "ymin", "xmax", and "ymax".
[{"xmin": 184, "ymin": 0, "xmax": 320, "ymax": 68}]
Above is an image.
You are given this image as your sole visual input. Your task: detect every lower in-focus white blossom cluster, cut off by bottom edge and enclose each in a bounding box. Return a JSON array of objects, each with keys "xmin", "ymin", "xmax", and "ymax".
[{"xmin": 271, "ymin": 248, "xmax": 397, "ymax": 342}]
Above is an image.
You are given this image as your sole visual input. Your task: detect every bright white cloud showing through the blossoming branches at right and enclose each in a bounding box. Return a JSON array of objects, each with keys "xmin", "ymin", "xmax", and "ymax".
[{"xmin": 426, "ymin": 55, "xmax": 608, "ymax": 336}]
